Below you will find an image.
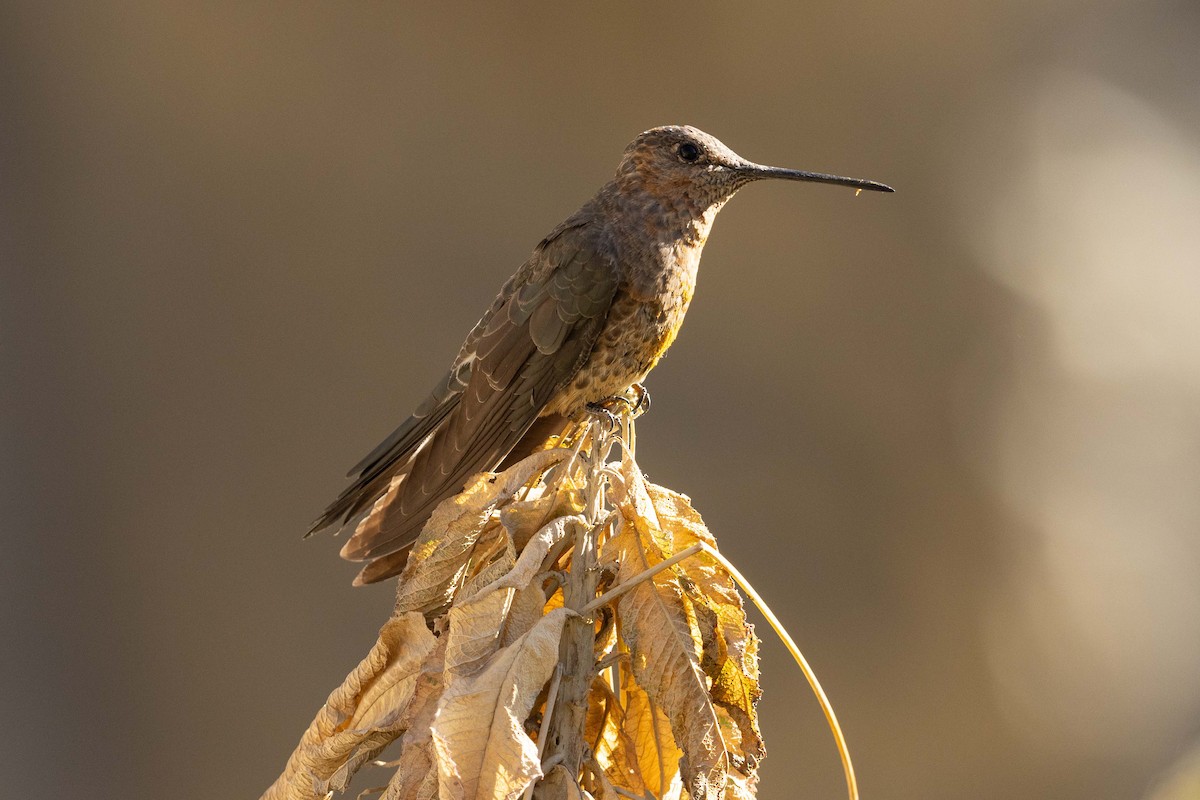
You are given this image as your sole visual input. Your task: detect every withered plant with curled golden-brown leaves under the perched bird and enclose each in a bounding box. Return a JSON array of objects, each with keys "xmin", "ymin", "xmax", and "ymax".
[{"xmin": 263, "ymin": 414, "xmax": 856, "ymax": 800}]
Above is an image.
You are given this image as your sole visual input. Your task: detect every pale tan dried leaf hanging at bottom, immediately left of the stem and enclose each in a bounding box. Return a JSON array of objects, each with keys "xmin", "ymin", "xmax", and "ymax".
[{"xmin": 433, "ymin": 609, "xmax": 569, "ymax": 800}]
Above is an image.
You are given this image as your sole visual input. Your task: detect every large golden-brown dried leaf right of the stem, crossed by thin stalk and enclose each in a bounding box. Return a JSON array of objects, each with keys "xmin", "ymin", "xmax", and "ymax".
[{"xmin": 607, "ymin": 458, "xmax": 763, "ymax": 796}]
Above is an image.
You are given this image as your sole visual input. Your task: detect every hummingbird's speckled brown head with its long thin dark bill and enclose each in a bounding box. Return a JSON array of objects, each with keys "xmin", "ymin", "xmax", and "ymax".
[{"xmin": 616, "ymin": 125, "xmax": 893, "ymax": 213}]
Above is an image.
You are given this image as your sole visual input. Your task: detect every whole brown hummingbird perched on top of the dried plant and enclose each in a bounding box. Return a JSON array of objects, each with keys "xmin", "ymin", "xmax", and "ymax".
[{"xmin": 310, "ymin": 126, "xmax": 892, "ymax": 583}]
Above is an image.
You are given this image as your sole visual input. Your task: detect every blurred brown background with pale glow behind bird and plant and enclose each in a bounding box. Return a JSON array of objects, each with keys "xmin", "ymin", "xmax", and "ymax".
[{"xmin": 0, "ymin": 0, "xmax": 1200, "ymax": 800}]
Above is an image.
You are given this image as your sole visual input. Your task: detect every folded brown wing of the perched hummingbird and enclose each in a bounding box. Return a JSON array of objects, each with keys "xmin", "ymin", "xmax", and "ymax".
[{"xmin": 326, "ymin": 230, "xmax": 617, "ymax": 579}]
